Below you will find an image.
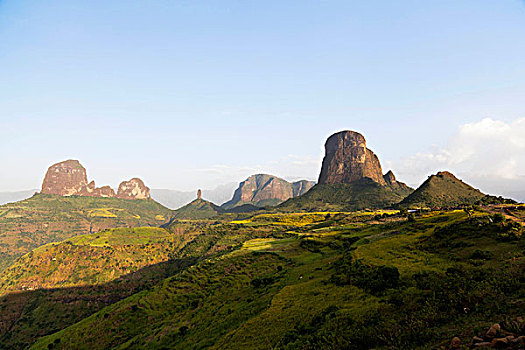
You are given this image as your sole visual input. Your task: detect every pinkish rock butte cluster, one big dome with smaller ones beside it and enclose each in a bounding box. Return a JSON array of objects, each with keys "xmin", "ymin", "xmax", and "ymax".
[{"xmin": 41, "ymin": 159, "xmax": 150, "ymax": 199}]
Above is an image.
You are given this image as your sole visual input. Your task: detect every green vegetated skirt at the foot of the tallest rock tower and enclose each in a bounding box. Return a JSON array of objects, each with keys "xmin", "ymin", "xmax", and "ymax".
[{"xmin": 278, "ymin": 178, "xmax": 412, "ymax": 212}]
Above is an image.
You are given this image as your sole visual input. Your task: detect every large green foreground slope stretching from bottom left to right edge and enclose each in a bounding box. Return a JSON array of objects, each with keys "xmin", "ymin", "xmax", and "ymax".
[{"xmin": 30, "ymin": 211, "xmax": 525, "ymax": 349}]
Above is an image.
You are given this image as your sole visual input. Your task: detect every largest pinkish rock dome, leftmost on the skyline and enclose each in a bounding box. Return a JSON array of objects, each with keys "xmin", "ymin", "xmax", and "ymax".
[{"xmin": 41, "ymin": 159, "xmax": 88, "ymax": 196}]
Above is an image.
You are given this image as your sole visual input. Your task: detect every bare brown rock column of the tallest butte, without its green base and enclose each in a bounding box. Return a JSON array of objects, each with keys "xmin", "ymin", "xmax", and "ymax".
[{"xmin": 318, "ymin": 131, "xmax": 386, "ymax": 185}]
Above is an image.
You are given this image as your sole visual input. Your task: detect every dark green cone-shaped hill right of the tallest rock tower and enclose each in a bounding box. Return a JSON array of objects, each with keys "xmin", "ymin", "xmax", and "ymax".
[{"xmin": 399, "ymin": 171, "xmax": 486, "ymax": 207}]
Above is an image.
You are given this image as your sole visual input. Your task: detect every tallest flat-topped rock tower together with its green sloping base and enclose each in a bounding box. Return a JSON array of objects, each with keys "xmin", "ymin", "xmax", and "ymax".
[{"xmin": 278, "ymin": 131, "xmax": 413, "ymax": 211}]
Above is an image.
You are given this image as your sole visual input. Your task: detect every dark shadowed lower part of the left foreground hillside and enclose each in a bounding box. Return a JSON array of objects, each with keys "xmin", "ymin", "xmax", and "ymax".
[{"xmin": 0, "ymin": 258, "xmax": 197, "ymax": 349}]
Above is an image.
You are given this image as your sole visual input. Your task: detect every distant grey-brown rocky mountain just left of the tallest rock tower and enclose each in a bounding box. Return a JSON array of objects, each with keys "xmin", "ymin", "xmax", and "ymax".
[{"xmin": 222, "ymin": 174, "xmax": 314, "ymax": 209}]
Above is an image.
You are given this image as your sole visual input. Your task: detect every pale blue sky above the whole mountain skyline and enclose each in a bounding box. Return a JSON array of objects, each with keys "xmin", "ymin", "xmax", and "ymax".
[{"xmin": 0, "ymin": 0, "xmax": 525, "ymax": 200}]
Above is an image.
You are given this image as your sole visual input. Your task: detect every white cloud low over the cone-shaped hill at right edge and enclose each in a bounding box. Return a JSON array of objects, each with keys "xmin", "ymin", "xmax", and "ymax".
[{"xmin": 389, "ymin": 118, "xmax": 525, "ymax": 199}]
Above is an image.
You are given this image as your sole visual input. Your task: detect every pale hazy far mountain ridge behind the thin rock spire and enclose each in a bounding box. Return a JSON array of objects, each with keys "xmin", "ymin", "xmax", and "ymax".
[{"xmin": 150, "ymin": 182, "xmax": 237, "ymax": 209}]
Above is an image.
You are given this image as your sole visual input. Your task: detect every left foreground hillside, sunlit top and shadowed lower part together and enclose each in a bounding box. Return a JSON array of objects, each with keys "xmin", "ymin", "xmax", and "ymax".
[{"xmin": 0, "ymin": 225, "xmax": 199, "ymax": 349}]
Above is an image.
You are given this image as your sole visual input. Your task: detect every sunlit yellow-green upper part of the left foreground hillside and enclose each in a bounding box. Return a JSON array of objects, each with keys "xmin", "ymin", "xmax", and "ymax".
[{"xmin": 0, "ymin": 228, "xmax": 191, "ymax": 295}]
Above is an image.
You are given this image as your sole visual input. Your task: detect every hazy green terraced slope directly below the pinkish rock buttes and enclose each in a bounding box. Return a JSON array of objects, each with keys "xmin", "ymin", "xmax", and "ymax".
[{"xmin": 0, "ymin": 194, "xmax": 172, "ymax": 271}]
